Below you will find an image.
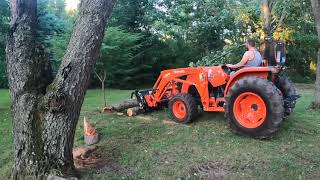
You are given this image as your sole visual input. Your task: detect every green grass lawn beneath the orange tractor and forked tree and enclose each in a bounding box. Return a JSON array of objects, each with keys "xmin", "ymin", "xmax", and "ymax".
[{"xmin": 0, "ymin": 90, "xmax": 320, "ymax": 179}]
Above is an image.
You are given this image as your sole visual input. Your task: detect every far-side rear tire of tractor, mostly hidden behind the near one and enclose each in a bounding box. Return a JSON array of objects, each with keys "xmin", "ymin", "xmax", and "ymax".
[{"xmin": 276, "ymin": 77, "xmax": 298, "ymax": 117}]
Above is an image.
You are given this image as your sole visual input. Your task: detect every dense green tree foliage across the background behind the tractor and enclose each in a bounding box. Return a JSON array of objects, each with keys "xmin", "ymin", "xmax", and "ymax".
[{"xmin": 0, "ymin": 0, "xmax": 318, "ymax": 89}]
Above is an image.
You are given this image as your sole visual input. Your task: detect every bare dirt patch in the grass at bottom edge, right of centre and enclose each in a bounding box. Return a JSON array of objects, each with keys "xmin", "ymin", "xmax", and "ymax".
[{"xmin": 190, "ymin": 161, "xmax": 232, "ymax": 180}]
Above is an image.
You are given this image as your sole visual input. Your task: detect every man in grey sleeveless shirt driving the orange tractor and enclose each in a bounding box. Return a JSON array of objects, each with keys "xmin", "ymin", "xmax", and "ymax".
[{"xmin": 227, "ymin": 39, "xmax": 262, "ymax": 69}]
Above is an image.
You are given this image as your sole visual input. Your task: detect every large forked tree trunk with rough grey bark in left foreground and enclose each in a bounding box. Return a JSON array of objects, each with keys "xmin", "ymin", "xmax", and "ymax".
[{"xmin": 7, "ymin": 0, "xmax": 113, "ymax": 179}]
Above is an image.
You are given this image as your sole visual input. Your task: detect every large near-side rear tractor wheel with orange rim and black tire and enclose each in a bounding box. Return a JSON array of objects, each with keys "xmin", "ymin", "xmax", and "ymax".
[{"xmin": 225, "ymin": 77, "xmax": 284, "ymax": 139}]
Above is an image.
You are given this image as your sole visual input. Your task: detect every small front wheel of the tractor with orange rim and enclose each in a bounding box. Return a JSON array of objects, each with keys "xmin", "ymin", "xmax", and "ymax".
[{"xmin": 169, "ymin": 93, "xmax": 198, "ymax": 124}]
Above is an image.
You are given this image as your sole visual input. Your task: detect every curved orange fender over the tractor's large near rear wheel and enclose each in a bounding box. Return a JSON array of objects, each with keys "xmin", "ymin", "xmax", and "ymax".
[{"xmin": 224, "ymin": 66, "xmax": 273, "ymax": 96}]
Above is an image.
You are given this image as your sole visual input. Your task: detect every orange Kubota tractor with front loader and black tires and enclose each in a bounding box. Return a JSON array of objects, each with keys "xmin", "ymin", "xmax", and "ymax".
[{"xmin": 134, "ymin": 39, "xmax": 299, "ymax": 138}]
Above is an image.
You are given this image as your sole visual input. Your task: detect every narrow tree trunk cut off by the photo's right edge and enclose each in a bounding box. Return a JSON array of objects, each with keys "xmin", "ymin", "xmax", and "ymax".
[{"xmin": 311, "ymin": 0, "xmax": 320, "ymax": 109}]
